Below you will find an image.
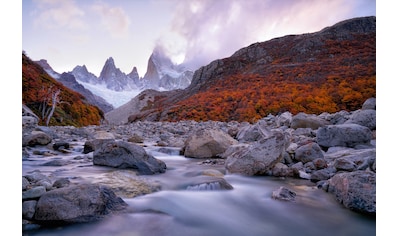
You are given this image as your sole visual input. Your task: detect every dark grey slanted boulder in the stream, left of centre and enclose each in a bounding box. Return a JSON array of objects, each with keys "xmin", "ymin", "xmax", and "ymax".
[{"xmin": 93, "ymin": 140, "xmax": 166, "ymax": 175}]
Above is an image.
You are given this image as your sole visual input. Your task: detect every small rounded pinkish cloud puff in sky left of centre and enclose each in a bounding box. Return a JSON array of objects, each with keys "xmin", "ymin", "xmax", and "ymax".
[{"xmin": 92, "ymin": 3, "xmax": 130, "ymax": 38}]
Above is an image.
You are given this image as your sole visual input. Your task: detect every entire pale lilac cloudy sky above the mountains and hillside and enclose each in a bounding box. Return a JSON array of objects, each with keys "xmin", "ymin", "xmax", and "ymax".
[{"xmin": 22, "ymin": 0, "xmax": 376, "ymax": 76}]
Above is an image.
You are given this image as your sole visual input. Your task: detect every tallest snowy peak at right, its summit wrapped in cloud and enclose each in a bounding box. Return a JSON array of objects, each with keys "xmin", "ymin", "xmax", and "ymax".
[{"xmin": 143, "ymin": 48, "xmax": 193, "ymax": 90}]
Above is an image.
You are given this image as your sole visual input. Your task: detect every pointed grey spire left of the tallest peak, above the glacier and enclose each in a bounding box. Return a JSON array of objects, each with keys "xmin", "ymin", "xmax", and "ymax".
[{"xmin": 98, "ymin": 57, "xmax": 137, "ymax": 91}]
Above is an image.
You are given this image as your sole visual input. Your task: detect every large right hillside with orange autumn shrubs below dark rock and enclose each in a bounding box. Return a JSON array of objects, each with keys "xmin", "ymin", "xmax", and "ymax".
[{"xmin": 118, "ymin": 16, "xmax": 376, "ymax": 122}]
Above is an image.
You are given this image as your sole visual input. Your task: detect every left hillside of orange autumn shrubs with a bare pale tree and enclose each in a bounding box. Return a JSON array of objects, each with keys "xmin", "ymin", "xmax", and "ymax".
[{"xmin": 22, "ymin": 54, "xmax": 104, "ymax": 126}]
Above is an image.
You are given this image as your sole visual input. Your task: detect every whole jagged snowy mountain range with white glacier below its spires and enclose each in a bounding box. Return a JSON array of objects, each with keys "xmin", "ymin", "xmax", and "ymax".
[{"xmin": 37, "ymin": 47, "xmax": 193, "ymax": 109}]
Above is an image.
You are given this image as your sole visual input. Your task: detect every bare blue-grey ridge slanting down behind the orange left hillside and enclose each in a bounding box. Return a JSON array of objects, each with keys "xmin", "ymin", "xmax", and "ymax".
[{"xmin": 58, "ymin": 73, "xmax": 114, "ymax": 113}]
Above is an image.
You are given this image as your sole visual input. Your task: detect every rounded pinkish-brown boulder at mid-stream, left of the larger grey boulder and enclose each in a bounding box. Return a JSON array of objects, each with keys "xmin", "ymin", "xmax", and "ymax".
[{"xmin": 184, "ymin": 129, "xmax": 238, "ymax": 158}]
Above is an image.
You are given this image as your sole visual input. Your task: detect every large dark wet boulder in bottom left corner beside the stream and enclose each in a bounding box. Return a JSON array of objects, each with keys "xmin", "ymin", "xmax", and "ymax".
[{"xmin": 34, "ymin": 184, "xmax": 127, "ymax": 225}]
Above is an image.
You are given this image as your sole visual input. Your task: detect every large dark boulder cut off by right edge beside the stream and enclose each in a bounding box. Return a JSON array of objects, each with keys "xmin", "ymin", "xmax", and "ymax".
[{"xmin": 328, "ymin": 171, "xmax": 376, "ymax": 215}]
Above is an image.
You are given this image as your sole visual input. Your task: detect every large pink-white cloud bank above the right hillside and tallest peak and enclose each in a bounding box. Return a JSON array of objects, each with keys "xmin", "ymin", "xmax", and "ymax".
[{"xmin": 158, "ymin": 0, "xmax": 376, "ymax": 69}]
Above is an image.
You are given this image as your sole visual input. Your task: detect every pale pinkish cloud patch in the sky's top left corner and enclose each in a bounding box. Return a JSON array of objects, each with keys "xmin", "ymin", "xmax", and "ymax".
[{"xmin": 33, "ymin": 0, "xmax": 87, "ymax": 30}]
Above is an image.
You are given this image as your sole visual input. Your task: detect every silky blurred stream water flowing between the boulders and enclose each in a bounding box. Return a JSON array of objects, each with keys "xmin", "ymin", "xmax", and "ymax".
[{"xmin": 23, "ymin": 144, "xmax": 376, "ymax": 236}]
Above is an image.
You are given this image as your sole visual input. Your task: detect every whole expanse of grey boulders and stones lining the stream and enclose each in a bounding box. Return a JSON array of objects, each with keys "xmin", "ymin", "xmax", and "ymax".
[{"xmin": 22, "ymin": 98, "xmax": 376, "ymax": 229}]
